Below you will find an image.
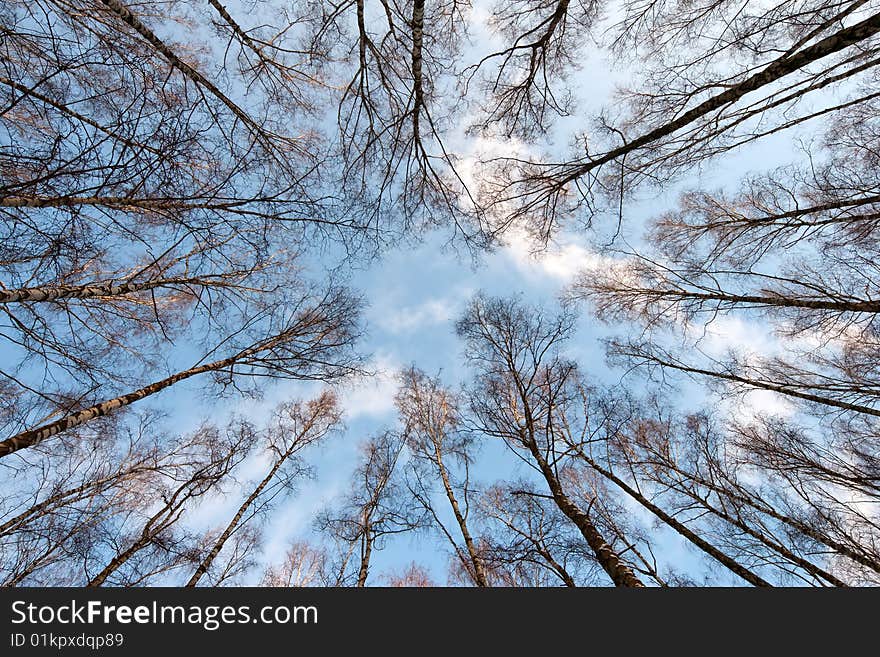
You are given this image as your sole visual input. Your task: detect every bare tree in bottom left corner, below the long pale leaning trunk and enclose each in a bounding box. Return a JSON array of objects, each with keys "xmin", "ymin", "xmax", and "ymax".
[{"xmin": 0, "ymin": 413, "xmax": 230, "ymax": 586}]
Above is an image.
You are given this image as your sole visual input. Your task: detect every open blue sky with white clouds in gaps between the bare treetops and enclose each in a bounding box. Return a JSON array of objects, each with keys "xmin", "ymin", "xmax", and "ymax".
[{"xmin": 0, "ymin": 2, "xmax": 856, "ymax": 584}]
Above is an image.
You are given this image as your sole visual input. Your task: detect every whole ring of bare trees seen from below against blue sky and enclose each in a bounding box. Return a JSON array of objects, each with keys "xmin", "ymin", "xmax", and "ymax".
[{"xmin": 0, "ymin": 0, "xmax": 880, "ymax": 587}]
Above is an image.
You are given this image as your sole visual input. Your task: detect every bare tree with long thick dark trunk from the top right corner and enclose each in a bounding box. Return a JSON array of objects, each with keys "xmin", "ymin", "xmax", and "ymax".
[{"xmin": 484, "ymin": 2, "xmax": 880, "ymax": 241}]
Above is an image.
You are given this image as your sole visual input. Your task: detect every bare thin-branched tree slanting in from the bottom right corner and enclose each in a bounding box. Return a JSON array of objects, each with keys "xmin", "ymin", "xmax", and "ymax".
[{"xmin": 587, "ymin": 404, "xmax": 871, "ymax": 586}]
